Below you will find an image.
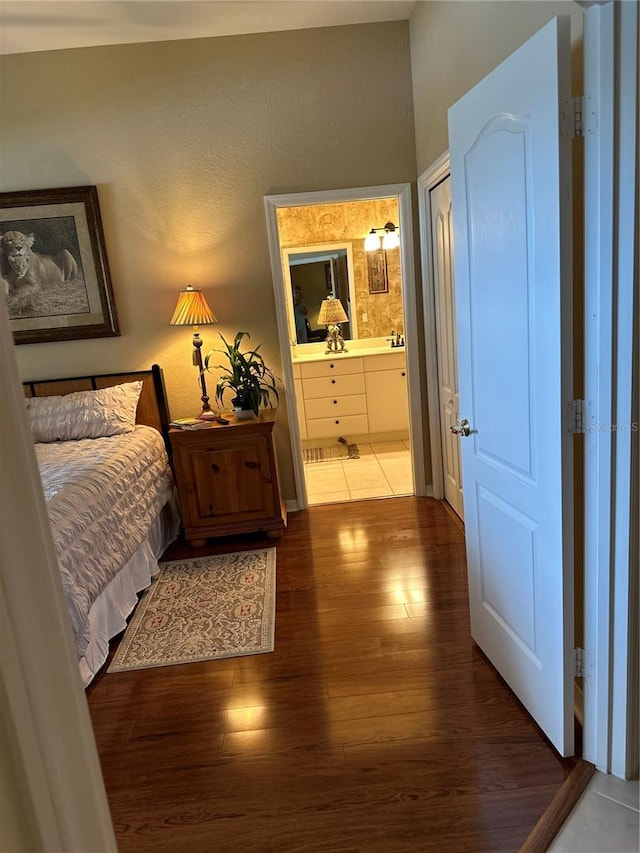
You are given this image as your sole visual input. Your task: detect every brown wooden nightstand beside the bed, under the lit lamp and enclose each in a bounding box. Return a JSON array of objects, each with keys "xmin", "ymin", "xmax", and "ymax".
[{"xmin": 169, "ymin": 409, "xmax": 287, "ymax": 547}]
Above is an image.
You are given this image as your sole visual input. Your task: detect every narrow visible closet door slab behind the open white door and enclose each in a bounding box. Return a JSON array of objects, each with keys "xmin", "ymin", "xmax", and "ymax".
[{"xmin": 429, "ymin": 177, "xmax": 464, "ymax": 518}]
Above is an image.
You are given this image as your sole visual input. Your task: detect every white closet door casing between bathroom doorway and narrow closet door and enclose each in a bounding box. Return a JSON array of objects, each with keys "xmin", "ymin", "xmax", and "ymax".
[{"xmin": 418, "ymin": 151, "xmax": 451, "ymax": 500}]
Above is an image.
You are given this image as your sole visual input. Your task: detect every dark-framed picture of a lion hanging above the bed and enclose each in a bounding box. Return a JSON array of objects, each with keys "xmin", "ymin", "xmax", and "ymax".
[{"xmin": 0, "ymin": 187, "xmax": 120, "ymax": 344}]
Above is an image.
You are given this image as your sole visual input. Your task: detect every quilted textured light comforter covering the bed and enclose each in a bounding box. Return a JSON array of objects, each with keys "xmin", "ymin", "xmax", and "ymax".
[{"xmin": 35, "ymin": 426, "xmax": 173, "ymax": 655}]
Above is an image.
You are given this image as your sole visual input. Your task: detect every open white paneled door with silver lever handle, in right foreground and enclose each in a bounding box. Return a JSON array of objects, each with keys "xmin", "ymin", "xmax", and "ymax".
[{"xmin": 449, "ymin": 19, "xmax": 573, "ymax": 755}]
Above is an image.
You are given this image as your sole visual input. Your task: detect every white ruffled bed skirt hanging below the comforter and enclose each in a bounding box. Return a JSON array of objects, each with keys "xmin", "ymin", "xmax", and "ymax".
[{"xmin": 80, "ymin": 497, "xmax": 180, "ymax": 687}]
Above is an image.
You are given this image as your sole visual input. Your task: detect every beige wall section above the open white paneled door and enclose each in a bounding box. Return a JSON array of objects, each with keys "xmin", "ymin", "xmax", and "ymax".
[{"xmin": 410, "ymin": 0, "xmax": 583, "ymax": 175}]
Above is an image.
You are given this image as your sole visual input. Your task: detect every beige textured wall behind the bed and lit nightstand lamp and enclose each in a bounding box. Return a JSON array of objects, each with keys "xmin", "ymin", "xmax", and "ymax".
[{"xmin": 0, "ymin": 22, "xmax": 416, "ymax": 498}]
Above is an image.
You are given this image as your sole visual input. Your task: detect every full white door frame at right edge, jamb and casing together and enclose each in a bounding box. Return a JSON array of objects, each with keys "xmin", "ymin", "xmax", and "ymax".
[{"xmin": 583, "ymin": 3, "xmax": 638, "ymax": 777}]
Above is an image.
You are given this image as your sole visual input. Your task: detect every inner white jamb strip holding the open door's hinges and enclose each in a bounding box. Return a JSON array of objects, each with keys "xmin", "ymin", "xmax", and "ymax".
[{"xmin": 583, "ymin": 4, "xmax": 613, "ymax": 773}]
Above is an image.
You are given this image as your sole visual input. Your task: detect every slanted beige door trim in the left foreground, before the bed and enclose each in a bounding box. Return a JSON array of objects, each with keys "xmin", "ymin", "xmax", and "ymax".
[{"xmin": 0, "ymin": 292, "xmax": 116, "ymax": 853}]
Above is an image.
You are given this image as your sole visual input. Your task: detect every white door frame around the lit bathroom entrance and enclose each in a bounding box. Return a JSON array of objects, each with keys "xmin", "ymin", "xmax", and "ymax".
[{"xmin": 264, "ymin": 183, "xmax": 427, "ymax": 509}]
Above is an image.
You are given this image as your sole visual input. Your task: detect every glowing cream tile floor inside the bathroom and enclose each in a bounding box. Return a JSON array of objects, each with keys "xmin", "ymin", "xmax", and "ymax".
[{"xmin": 304, "ymin": 440, "xmax": 413, "ymax": 506}]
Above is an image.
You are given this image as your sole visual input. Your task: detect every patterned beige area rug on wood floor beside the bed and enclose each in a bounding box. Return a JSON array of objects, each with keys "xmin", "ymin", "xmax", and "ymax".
[{"xmin": 108, "ymin": 548, "xmax": 276, "ymax": 672}]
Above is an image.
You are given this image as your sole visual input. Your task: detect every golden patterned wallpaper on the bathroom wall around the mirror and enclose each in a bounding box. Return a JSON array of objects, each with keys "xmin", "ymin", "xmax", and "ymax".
[{"xmin": 277, "ymin": 198, "xmax": 404, "ymax": 338}]
